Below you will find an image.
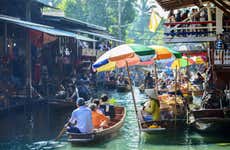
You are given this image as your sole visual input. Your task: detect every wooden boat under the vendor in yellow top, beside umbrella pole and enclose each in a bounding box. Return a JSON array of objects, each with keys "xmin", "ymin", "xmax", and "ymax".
[{"xmin": 138, "ymin": 110, "xmax": 186, "ymax": 134}]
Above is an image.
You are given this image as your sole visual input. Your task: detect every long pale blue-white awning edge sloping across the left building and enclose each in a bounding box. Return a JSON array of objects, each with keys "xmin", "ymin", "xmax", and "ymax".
[{"xmin": 0, "ymin": 15, "xmax": 96, "ymax": 42}]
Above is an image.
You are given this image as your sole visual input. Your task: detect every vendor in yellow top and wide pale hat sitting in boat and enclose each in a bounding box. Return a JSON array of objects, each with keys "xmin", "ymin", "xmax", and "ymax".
[{"xmin": 143, "ymin": 89, "xmax": 160, "ymax": 121}]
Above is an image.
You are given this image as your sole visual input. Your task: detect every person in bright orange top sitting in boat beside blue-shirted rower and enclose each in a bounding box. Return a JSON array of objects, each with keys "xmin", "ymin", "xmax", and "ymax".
[{"xmin": 89, "ymin": 104, "xmax": 109, "ymax": 129}]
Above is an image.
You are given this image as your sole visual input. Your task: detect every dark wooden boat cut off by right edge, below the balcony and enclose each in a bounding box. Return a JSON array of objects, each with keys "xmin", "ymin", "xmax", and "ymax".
[{"xmin": 189, "ymin": 108, "xmax": 230, "ymax": 132}]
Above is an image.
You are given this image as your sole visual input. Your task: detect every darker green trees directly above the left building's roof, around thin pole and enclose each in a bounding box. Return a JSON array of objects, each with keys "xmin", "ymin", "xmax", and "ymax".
[{"xmin": 47, "ymin": 0, "xmax": 137, "ymax": 40}]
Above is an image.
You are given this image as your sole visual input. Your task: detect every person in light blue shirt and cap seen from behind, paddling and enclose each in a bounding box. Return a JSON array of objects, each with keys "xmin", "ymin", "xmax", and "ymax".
[{"xmin": 66, "ymin": 98, "xmax": 93, "ymax": 133}]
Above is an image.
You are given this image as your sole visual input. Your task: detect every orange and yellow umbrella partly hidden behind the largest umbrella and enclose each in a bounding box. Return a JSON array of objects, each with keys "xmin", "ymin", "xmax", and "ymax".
[{"xmin": 149, "ymin": 45, "xmax": 182, "ymax": 60}]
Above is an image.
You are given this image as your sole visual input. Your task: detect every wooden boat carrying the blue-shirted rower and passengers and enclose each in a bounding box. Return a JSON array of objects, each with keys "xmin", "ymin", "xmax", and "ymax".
[{"xmin": 67, "ymin": 107, "xmax": 126, "ymax": 144}]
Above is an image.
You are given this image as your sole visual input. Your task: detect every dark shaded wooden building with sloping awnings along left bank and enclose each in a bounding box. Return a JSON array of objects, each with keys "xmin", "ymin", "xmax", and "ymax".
[{"xmin": 0, "ymin": 0, "xmax": 116, "ymax": 102}]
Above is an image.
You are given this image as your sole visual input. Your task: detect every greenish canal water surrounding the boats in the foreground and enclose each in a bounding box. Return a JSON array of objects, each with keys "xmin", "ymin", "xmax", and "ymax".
[{"xmin": 0, "ymin": 89, "xmax": 230, "ymax": 150}]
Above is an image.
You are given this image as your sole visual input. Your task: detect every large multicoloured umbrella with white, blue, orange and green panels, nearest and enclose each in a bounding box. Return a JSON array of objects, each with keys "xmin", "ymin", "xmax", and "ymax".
[{"xmin": 93, "ymin": 44, "xmax": 155, "ymax": 72}]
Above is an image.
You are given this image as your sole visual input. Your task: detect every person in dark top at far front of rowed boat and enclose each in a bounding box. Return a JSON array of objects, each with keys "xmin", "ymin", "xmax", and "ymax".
[{"xmin": 100, "ymin": 94, "xmax": 115, "ymax": 119}]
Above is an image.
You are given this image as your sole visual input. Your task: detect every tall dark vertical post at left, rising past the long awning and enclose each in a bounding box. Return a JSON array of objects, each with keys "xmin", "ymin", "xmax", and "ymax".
[{"xmin": 26, "ymin": 1, "xmax": 32, "ymax": 98}]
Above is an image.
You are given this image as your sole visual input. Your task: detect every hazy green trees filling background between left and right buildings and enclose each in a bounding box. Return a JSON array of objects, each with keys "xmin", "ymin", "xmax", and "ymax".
[{"xmin": 47, "ymin": 0, "xmax": 164, "ymax": 45}]
